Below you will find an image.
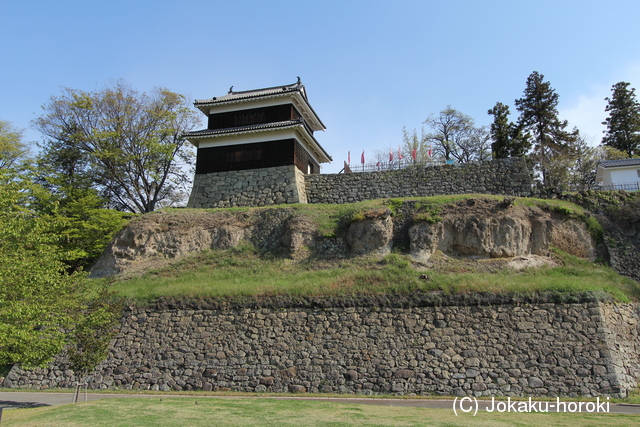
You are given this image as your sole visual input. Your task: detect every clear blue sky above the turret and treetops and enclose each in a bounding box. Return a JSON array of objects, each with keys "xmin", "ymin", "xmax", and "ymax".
[{"xmin": 0, "ymin": 0, "xmax": 640, "ymax": 173}]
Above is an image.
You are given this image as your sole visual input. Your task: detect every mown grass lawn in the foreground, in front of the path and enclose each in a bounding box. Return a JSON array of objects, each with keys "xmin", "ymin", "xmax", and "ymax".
[{"xmin": 2, "ymin": 397, "xmax": 640, "ymax": 427}]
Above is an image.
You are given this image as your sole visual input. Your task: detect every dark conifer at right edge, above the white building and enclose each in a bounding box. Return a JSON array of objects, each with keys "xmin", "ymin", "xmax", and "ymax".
[{"xmin": 602, "ymin": 82, "xmax": 640, "ymax": 157}]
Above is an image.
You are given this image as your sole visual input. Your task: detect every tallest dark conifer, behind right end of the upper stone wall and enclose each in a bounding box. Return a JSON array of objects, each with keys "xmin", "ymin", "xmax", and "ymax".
[{"xmin": 515, "ymin": 71, "xmax": 578, "ymax": 188}]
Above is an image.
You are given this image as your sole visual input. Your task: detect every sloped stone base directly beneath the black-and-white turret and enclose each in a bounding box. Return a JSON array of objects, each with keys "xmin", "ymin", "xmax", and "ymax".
[{"xmin": 187, "ymin": 166, "xmax": 307, "ymax": 208}]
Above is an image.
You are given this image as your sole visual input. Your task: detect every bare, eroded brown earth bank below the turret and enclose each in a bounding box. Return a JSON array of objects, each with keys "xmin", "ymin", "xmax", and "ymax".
[{"xmin": 92, "ymin": 197, "xmax": 607, "ymax": 277}]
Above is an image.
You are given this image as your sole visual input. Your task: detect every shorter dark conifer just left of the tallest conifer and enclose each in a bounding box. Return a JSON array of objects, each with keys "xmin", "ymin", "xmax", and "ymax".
[{"xmin": 487, "ymin": 102, "xmax": 531, "ymax": 159}]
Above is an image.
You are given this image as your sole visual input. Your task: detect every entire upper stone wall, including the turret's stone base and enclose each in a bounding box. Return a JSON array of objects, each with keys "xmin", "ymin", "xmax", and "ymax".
[{"xmin": 188, "ymin": 158, "xmax": 532, "ymax": 208}]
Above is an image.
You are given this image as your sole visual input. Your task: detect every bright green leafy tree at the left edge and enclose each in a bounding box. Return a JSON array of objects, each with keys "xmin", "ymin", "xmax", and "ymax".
[{"xmin": 0, "ymin": 169, "xmax": 120, "ymax": 366}]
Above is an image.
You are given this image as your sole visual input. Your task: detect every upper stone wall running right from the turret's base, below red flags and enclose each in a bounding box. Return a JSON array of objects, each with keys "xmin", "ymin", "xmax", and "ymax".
[{"xmin": 304, "ymin": 158, "xmax": 532, "ymax": 203}]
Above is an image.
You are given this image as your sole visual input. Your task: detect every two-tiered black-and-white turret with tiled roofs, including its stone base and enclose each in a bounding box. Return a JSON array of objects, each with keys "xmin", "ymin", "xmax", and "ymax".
[{"xmin": 185, "ymin": 78, "xmax": 332, "ymax": 208}]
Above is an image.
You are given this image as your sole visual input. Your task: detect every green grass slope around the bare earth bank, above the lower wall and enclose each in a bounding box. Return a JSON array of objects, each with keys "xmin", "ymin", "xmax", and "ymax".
[{"xmin": 105, "ymin": 195, "xmax": 640, "ymax": 301}]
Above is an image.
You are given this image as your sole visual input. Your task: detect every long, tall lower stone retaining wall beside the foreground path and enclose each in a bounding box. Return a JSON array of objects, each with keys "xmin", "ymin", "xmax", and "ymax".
[{"xmin": 3, "ymin": 296, "xmax": 640, "ymax": 396}]
